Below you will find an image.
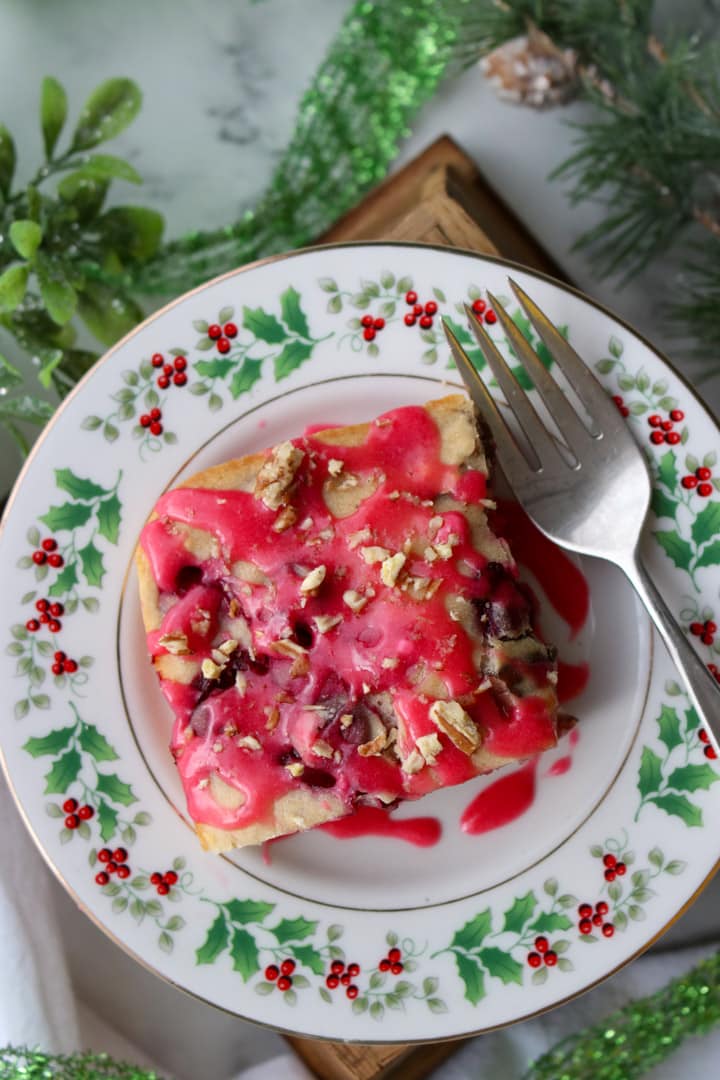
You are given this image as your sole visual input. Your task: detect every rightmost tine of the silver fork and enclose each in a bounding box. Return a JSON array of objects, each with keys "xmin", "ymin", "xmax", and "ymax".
[{"xmin": 508, "ymin": 278, "xmax": 631, "ymax": 440}]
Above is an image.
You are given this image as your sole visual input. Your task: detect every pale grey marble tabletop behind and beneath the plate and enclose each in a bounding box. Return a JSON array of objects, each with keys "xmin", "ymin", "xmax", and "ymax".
[{"xmin": 0, "ymin": 0, "xmax": 720, "ymax": 1078}]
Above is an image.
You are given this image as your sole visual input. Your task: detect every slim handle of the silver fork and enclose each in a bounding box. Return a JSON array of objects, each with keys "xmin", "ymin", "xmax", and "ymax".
[{"xmin": 623, "ymin": 552, "xmax": 720, "ymax": 750}]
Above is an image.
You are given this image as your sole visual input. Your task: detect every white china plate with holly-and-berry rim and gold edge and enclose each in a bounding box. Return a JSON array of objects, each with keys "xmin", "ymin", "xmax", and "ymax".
[{"xmin": 0, "ymin": 244, "xmax": 720, "ymax": 1042}]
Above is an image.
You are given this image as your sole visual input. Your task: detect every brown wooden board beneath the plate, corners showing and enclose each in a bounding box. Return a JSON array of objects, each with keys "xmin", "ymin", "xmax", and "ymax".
[{"xmin": 287, "ymin": 135, "xmax": 567, "ymax": 1080}]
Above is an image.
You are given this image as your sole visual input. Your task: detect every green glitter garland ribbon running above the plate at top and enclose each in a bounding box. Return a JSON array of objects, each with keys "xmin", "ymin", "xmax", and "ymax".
[{"xmin": 129, "ymin": 0, "xmax": 479, "ymax": 295}]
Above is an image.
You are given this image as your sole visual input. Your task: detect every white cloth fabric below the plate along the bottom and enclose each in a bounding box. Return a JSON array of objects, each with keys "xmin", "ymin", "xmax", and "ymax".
[{"xmin": 0, "ymin": 781, "xmax": 720, "ymax": 1080}]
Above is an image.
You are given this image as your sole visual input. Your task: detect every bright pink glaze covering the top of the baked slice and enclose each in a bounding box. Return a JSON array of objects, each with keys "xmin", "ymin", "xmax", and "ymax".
[{"xmin": 141, "ymin": 406, "xmax": 557, "ymax": 828}]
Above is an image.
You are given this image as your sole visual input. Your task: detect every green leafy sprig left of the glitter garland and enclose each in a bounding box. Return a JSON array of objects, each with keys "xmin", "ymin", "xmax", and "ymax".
[{"xmin": 0, "ymin": 77, "xmax": 163, "ymax": 450}]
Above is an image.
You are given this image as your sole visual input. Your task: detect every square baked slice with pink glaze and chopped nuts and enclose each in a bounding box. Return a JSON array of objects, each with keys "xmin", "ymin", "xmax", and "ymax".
[{"xmin": 137, "ymin": 395, "xmax": 558, "ymax": 851}]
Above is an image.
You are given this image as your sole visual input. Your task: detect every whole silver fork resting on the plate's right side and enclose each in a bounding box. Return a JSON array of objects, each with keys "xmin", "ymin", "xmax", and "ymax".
[{"xmin": 444, "ymin": 279, "xmax": 720, "ymax": 742}]
